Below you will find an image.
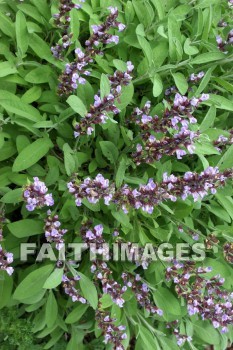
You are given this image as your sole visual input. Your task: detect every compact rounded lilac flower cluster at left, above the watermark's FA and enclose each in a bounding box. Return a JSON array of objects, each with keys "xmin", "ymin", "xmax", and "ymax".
[{"xmin": 23, "ymin": 177, "xmax": 54, "ymax": 211}]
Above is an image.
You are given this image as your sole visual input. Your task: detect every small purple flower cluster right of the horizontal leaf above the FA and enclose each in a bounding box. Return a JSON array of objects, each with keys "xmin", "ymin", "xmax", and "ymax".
[{"xmin": 44, "ymin": 210, "xmax": 67, "ymax": 250}]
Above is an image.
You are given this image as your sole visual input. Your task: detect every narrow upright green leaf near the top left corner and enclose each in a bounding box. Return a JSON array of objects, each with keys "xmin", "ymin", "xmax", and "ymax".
[{"xmin": 15, "ymin": 11, "xmax": 29, "ymax": 55}]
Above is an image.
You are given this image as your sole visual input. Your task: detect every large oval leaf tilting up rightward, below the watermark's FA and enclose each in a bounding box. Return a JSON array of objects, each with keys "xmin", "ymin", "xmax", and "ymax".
[{"xmin": 13, "ymin": 264, "xmax": 53, "ymax": 302}]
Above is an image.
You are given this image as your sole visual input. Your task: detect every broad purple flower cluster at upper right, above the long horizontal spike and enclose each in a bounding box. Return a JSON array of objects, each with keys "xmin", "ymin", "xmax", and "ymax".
[{"xmin": 131, "ymin": 93, "xmax": 209, "ymax": 165}]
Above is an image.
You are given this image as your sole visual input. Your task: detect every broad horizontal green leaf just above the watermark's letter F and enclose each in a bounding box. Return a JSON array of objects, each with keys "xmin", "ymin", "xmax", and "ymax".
[{"xmin": 7, "ymin": 219, "xmax": 44, "ymax": 238}]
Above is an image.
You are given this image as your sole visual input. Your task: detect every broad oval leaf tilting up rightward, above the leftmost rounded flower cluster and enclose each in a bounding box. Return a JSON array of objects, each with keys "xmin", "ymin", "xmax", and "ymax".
[{"xmin": 12, "ymin": 138, "xmax": 53, "ymax": 172}]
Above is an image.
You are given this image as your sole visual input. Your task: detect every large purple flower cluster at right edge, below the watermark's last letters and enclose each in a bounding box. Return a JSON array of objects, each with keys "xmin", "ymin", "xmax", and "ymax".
[{"xmin": 166, "ymin": 261, "xmax": 233, "ymax": 333}]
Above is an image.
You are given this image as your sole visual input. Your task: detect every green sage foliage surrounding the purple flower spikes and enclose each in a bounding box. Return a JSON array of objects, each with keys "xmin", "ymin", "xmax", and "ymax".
[{"xmin": 0, "ymin": 0, "xmax": 233, "ymax": 350}]
